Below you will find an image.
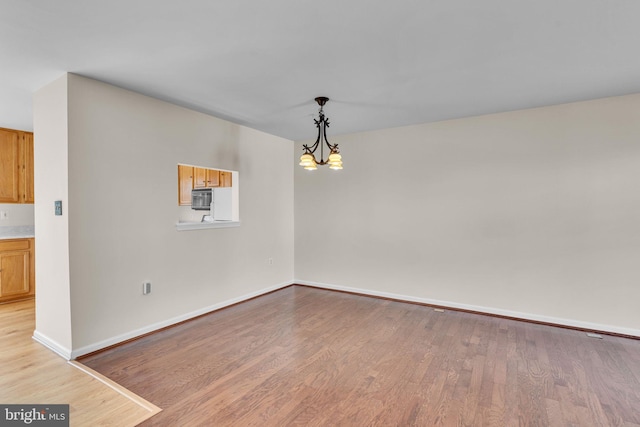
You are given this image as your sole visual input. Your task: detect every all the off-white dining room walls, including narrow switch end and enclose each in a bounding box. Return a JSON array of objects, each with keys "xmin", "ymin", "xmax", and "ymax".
[{"xmin": 34, "ymin": 75, "xmax": 640, "ymax": 357}]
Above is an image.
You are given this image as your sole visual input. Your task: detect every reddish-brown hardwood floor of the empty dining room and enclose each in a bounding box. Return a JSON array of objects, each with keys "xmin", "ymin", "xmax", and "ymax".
[{"xmin": 82, "ymin": 286, "xmax": 640, "ymax": 427}]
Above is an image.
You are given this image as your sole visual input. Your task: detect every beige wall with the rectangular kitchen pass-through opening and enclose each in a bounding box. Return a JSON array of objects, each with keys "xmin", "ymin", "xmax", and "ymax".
[{"xmin": 36, "ymin": 75, "xmax": 293, "ymax": 356}]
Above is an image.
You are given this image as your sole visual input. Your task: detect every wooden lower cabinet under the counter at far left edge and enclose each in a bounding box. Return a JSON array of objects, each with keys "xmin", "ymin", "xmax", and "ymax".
[{"xmin": 0, "ymin": 239, "xmax": 35, "ymax": 302}]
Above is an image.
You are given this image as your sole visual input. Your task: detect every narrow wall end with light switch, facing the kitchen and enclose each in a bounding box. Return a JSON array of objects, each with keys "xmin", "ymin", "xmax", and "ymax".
[{"xmin": 33, "ymin": 76, "xmax": 72, "ymax": 355}]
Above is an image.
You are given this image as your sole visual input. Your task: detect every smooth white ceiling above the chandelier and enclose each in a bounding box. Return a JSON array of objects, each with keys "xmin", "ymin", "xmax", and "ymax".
[{"xmin": 0, "ymin": 0, "xmax": 640, "ymax": 140}]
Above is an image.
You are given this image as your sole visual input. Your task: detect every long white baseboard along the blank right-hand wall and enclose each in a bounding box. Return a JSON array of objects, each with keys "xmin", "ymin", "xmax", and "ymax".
[{"xmin": 294, "ymin": 280, "xmax": 640, "ymax": 338}]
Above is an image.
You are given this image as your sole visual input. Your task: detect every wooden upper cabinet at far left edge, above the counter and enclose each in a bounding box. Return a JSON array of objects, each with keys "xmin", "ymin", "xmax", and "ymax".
[{"xmin": 0, "ymin": 128, "xmax": 34, "ymax": 203}]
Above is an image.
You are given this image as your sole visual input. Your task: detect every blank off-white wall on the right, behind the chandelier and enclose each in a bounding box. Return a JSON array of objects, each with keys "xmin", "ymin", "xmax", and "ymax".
[{"xmin": 294, "ymin": 95, "xmax": 640, "ymax": 336}]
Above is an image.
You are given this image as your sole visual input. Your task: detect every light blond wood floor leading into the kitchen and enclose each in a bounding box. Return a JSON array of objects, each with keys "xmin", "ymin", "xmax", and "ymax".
[{"xmin": 0, "ymin": 300, "xmax": 159, "ymax": 427}]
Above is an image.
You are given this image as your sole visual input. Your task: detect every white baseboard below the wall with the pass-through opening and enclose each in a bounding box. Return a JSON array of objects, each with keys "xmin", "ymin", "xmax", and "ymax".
[{"xmin": 68, "ymin": 282, "xmax": 294, "ymax": 360}]
